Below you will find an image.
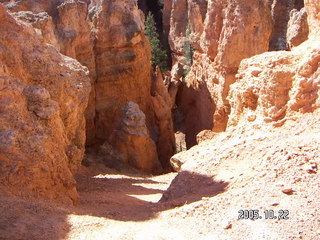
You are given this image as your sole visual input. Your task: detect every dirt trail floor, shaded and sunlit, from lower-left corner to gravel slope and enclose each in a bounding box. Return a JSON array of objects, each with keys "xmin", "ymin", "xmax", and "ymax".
[{"xmin": 0, "ymin": 159, "xmax": 230, "ymax": 240}]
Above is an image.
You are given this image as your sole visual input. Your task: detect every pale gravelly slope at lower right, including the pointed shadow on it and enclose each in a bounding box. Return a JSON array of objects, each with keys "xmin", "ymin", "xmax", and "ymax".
[{"xmin": 162, "ymin": 109, "xmax": 320, "ymax": 240}]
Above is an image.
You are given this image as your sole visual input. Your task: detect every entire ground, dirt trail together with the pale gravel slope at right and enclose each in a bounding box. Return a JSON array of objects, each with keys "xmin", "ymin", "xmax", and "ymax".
[{"xmin": 0, "ymin": 115, "xmax": 320, "ymax": 240}]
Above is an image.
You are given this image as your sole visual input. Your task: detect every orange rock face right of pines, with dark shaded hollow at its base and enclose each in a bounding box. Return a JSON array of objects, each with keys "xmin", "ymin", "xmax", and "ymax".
[{"xmin": 165, "ymin": 0, "xmax": 272, "ymax": 147}]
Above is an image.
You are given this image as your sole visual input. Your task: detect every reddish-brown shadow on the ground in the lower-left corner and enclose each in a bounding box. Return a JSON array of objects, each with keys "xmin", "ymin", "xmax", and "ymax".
[{"xmin": 0, "ymin": 192, "xmax": 71, "ymax": 240}]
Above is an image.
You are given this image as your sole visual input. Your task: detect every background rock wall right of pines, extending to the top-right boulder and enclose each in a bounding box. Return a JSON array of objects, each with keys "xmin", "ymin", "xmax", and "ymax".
[{"xmin": 163, "ymin": 0, "xmax": 309, "ymax": 147}]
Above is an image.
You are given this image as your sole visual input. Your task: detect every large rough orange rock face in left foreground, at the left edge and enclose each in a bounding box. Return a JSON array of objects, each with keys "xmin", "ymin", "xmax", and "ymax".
[{"xmin": 0, "ymin": 5, "xmax": 90, "ymax": 204}]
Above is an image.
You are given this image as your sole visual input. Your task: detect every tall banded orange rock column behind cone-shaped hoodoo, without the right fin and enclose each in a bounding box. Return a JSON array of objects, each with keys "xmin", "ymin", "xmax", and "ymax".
[{"xmin": 94, "ymin": 1, "xmax": 152, "ymax": 141}]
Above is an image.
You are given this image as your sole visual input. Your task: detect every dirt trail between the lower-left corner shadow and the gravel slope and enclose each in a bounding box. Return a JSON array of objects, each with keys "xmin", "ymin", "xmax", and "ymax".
[{"xmin": 65, "ymin": 166, "xmax": 218, "ymax": 240}]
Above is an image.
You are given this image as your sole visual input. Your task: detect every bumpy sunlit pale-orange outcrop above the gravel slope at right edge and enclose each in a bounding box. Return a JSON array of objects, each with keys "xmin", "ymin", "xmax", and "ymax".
[{"xmin": 171, "ymin": 0, "xmax": 320, "ymax": 170}]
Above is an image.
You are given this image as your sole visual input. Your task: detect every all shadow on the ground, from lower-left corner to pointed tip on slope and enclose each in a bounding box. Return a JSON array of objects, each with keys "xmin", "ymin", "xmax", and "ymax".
[{"xmin": 0, "ymin": 172, "xmax": 228, "ymax": 240}]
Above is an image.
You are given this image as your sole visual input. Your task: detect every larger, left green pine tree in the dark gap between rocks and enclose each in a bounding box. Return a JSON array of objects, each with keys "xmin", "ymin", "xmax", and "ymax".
[{"xmin": 145, "ymin": 12, "xmax": 168, "ymax": 72}]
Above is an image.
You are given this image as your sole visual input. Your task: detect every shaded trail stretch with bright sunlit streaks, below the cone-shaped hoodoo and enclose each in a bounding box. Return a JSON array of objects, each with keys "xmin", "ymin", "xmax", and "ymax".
[{"xmin": 76, "ymin": 166, "xmax": 176, "ymax": 221}]
